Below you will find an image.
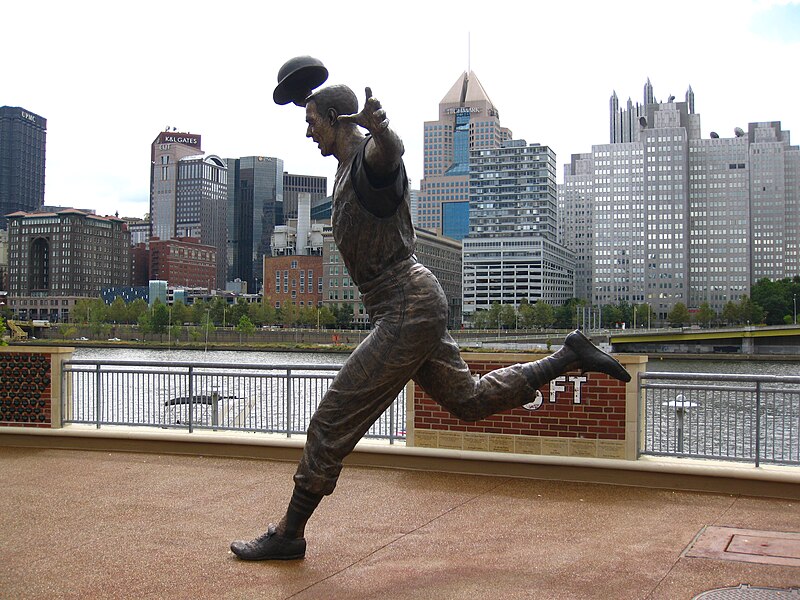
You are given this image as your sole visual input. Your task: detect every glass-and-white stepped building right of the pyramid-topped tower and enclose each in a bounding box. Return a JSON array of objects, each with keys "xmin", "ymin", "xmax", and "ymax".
[{"xmin": 463, "ymin": 140, "xmax": 575, "ymax": 317}]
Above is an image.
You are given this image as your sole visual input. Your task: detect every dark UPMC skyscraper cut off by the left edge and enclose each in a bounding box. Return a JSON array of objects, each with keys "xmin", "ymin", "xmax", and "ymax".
[{"xmin": 0, "ymin": 106, "xmax": 47, "ymax": 229}]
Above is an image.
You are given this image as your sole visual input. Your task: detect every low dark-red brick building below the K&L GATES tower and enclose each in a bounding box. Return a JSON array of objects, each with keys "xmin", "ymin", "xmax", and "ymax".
[{"xmin": 149, "ymin": 237, "xmax": 217, "ymax": 289}]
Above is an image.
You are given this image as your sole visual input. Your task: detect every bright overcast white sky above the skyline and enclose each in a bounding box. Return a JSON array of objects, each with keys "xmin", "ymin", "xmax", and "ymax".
[{"xmin": 0, "ymin": 0, "xmax": 800, "ymax": 217}]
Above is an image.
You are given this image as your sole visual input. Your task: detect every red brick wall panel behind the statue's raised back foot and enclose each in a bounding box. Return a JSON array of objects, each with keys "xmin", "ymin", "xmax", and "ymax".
[{"xmin": 414, "ymin": 360, "xmax": 625, "ymax": 440}]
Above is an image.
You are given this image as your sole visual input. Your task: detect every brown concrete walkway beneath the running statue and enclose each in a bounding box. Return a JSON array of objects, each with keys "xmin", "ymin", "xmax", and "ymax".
[{"xmin": 0, "ymin": 447, "xmax": 800, "ymax": 600}]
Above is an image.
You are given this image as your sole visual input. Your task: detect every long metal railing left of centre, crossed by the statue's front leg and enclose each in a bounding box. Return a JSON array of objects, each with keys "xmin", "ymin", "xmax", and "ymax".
[{"xmin": 61, "ymin": 360, "xmax": 406, "ymax": 443}]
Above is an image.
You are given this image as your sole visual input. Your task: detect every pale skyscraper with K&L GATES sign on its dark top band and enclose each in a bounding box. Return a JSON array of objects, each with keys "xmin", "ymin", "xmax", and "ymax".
[{"xmin": 150, "ymin": 128, "xmax": 203, "ymax": 240}]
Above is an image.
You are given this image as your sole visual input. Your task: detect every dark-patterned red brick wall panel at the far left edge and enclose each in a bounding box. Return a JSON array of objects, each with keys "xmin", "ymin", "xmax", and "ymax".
[{"xmin": 0, "ymin": 352, "xmax": 52, "ymax": 427}]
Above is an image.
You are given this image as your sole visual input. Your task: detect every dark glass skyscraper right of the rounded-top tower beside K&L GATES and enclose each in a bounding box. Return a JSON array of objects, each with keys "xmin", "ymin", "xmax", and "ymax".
[{"xmin": 227, "ymin": 156, "xmax": 284, "ymax": 292}]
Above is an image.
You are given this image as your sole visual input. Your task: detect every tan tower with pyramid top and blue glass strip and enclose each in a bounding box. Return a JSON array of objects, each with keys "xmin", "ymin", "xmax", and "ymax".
[{"xmin": 416, "ymin": 71, "xmax": 511, "ymax": 240}]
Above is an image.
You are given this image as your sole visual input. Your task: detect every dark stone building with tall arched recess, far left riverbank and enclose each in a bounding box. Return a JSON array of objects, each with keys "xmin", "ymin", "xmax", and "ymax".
[{"xmin": 8, "ymin": 209, "xmax": 131, "ymax": 321}]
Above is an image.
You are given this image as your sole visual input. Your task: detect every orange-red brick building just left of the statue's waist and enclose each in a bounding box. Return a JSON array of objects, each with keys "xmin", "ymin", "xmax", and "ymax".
[{"xmin": 264, "ymin": 255, "xmax": 322, "ymax": 308}]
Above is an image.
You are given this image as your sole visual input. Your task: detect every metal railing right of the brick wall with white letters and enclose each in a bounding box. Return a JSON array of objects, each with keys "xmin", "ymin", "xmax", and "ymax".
[{"xmin": 639, "ymin": 372, "xmax": 800, "ymax": 466}]
